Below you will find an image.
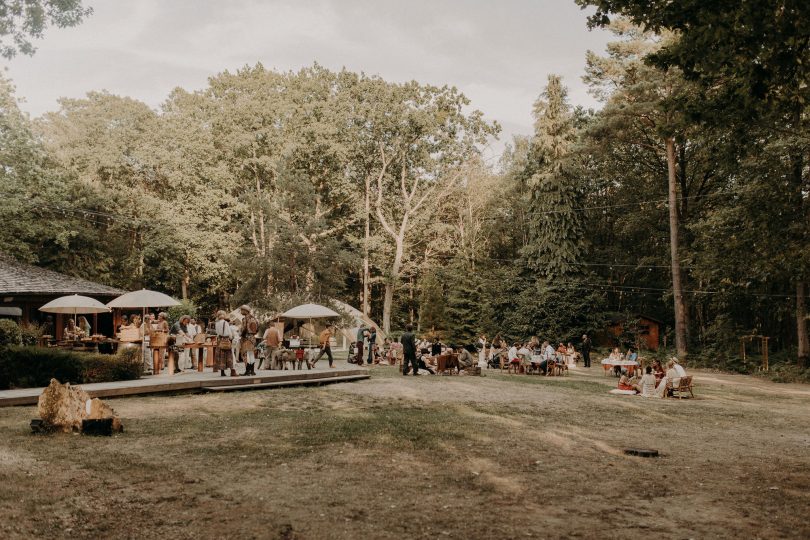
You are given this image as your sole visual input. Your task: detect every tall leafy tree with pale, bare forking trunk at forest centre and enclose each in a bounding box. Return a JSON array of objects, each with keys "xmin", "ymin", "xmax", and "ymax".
[{"xmin": 367, "ymin": 81, "xmax": 498, "ymax": 332}]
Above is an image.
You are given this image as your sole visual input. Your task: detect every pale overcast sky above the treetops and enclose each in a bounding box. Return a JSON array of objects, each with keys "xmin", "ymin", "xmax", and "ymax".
[{"xmin": 5, "ymin": 0, "xmax": 610, "ymax": 154}]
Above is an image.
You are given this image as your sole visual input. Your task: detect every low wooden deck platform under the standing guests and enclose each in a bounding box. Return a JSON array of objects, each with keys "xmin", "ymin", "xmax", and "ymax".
[{"xmin": 0, "ymin": 367, "xmax": 369, "ymax": 407}]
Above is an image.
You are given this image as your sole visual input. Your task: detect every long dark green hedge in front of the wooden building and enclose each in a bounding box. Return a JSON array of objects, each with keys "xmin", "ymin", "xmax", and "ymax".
[{"xmin": 0, "ymin": 346, "xmax": 143, "ymax": 390}]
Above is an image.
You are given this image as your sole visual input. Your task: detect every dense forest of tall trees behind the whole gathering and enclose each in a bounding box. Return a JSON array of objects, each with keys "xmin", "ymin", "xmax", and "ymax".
[{"xmin": 0, "ymin": 0, "xmax": 810, "ymax": 372}]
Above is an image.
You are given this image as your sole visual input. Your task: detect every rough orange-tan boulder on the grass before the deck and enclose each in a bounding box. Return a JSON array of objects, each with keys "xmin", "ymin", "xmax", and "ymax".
[{"xmin": 37, "ymin": 379, "xmax": 123, "ymax": 433}]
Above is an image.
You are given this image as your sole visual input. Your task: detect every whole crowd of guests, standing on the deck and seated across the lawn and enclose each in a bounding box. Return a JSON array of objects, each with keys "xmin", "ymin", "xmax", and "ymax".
[{"xmin": 110, "ymin": 305, "xmax": 686, "ymax": 397}]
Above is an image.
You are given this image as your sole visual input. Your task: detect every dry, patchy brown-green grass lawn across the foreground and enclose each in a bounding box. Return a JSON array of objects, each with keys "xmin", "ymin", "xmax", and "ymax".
[{"xmin": 0, "ymin": 368, "xmax": 810, "ymax": 539}]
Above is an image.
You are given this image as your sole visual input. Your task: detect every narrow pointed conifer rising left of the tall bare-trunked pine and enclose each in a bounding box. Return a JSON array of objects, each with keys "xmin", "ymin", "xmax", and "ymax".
[{"xmin": 523, "ymin": 75, "xmax": 582, "ymax": 278}]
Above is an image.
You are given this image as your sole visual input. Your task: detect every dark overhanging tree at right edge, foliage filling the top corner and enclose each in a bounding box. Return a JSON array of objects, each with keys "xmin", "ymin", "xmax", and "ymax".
[{"xmin": 577, "ymin": 0, "xmax": 810, "ymax": 362}]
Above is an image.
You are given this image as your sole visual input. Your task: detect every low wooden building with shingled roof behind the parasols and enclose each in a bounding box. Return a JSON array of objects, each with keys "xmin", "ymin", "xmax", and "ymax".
[{"xmin": 0, "ymin": 253, "xmax": 126, "ymax": 339}]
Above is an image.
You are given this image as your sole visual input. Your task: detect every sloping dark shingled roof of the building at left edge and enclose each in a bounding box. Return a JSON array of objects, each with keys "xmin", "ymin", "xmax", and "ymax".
[{"xmin": 0, "ymin": 253, "xmax": 126, "ymax": 296}]
